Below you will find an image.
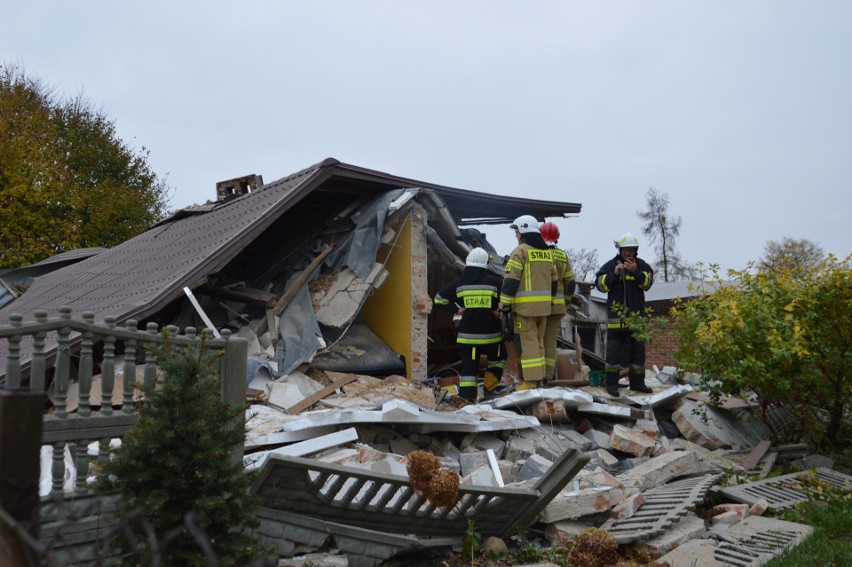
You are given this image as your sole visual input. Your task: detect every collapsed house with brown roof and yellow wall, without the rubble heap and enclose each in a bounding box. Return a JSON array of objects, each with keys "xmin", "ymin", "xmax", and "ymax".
[{"xmin": 0, "ymin": 159, "xmax": 581, "ymax": 379}]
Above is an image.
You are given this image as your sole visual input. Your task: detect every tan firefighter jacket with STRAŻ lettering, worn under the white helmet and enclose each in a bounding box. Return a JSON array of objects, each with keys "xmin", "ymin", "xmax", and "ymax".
[{"xmin": 500, "ymin": 241, "xmax": 557, "ymax": 317}]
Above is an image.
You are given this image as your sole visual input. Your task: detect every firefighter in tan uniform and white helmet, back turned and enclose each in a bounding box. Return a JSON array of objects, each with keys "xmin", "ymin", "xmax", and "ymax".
[{"xmin": 500, "ymin": 215, "xmax": 556, "ymax": 390}]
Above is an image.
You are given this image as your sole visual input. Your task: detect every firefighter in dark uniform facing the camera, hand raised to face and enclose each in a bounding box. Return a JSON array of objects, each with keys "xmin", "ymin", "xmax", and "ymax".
[{"xmin": 595, "ymin": 232, "xmax": 654, "ymax": 398}]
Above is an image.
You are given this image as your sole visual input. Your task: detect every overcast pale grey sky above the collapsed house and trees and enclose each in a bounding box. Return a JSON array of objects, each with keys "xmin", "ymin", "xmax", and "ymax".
[{"xmin": 0, "ymin": 0, "xmax": 852, "ymax": 276}]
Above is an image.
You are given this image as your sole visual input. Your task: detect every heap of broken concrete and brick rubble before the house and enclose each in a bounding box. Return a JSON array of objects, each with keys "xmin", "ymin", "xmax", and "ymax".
[{"xmin": 233, "ymin": 364, "xmax": 845, "ymax": 565}]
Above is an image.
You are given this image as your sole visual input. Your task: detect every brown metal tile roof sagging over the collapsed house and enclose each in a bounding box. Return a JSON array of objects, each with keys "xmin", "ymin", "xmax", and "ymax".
[{"xmin": 0, "ymin": 158, "xmax": 580, "ymax": 372}]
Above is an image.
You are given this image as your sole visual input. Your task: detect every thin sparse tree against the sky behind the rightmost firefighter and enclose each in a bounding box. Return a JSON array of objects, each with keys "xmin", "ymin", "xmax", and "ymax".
[{"xmin": 636, "ymin": 187, "xmax": 691, "ymax": 282}]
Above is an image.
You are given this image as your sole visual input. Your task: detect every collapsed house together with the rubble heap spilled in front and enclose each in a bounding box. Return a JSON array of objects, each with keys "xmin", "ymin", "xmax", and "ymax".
[{"xmin": 0, "ymin": 160, "xmax": 850, "ymax": 567}]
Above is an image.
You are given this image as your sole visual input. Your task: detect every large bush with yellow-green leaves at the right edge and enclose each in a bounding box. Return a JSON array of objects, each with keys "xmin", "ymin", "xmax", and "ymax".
[{"xmin": 673, "ymin": 255, "xmax": 852, "ymax": 446}]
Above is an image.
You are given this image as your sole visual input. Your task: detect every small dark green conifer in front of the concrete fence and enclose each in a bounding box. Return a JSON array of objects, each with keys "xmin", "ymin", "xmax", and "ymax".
[{"xmin": 97, "ymin": 336, "xmax": 263, "ymax": 567}]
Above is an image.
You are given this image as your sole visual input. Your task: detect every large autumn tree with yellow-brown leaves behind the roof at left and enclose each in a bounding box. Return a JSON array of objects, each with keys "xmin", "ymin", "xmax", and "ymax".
[{"xmin": 0, "ymin": 65, "xmax": 168, "ymax": 268}]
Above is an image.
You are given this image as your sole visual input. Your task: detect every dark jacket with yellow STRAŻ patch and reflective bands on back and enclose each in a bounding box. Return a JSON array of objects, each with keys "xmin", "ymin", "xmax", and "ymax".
[{"xmin": 434, "ymin": 266, "xmax": 503, "ymax": 346}]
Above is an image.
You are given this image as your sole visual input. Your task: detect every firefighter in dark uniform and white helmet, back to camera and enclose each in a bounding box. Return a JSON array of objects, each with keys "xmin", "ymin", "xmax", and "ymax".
[{"xmin": 434, "ymin": 248, "xmax": 506, "ymax": 403}]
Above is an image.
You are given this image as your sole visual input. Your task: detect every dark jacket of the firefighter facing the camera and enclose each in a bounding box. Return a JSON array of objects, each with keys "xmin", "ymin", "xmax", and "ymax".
[{"xmin": 595, "ymin": 254, "xmax": 654, "ymax": 329}]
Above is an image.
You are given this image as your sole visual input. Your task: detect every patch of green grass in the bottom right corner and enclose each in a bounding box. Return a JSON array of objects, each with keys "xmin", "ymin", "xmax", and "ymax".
[{"xmin": 766, "ymin": 492, "xmax": 852, "ymax": 567}]
